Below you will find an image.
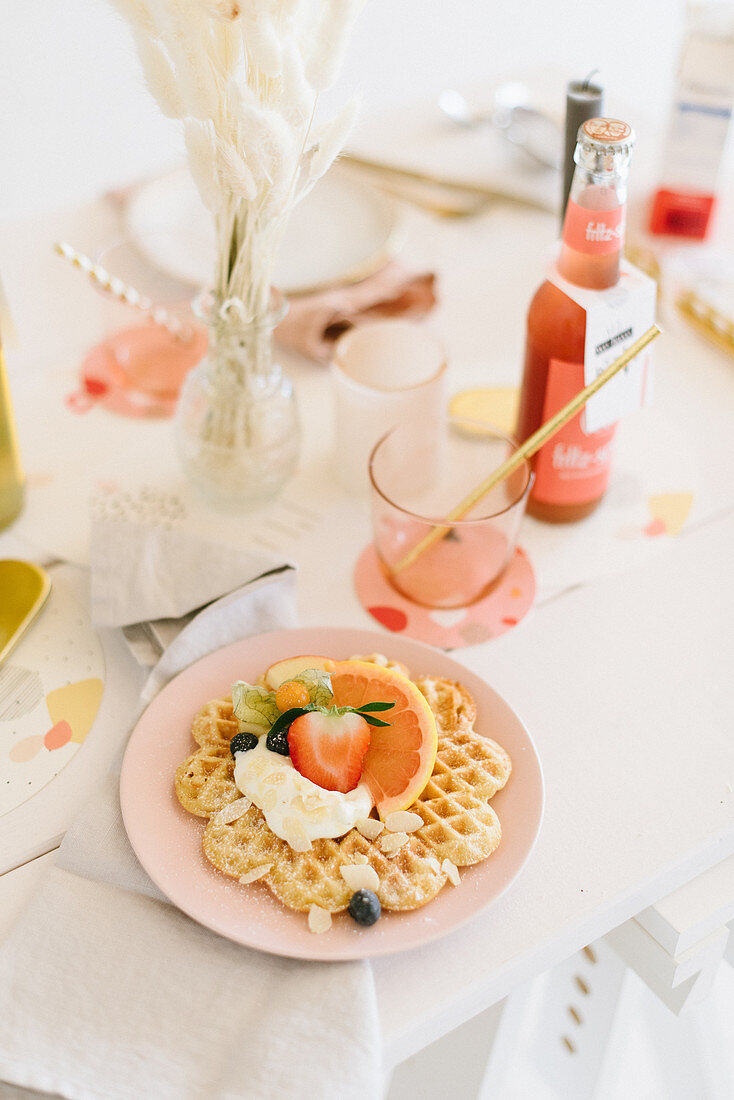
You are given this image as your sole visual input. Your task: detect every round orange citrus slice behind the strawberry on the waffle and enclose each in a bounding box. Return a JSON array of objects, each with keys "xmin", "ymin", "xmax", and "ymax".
[{"xmin": 329, "ymin": 661, "xmax": 438, "ymax": 820}]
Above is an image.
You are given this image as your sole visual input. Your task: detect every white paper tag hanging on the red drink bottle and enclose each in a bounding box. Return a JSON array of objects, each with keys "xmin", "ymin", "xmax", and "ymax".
[{"xmin": 550, "ymin": 260, "xmax": 656, "ymax": 433}]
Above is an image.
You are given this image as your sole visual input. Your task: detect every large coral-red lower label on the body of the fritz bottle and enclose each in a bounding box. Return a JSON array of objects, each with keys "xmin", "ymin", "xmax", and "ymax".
[{"xmin": 533, "ymin": 359, "xmax": 616, "ymax": 505}]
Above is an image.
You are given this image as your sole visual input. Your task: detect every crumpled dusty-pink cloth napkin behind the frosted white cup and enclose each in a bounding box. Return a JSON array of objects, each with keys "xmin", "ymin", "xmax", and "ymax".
[{"xmin": 275, "ymin": 262, "xmax": 436, "ymax": 363}]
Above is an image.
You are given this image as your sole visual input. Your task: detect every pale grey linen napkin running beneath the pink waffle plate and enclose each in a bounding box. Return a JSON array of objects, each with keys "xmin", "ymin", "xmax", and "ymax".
[{"xmin": 0, "ymin": 547, "xmax": 382, "ymax": 1100}]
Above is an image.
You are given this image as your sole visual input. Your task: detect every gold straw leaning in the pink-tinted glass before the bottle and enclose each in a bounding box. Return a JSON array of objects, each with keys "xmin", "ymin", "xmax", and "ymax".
[{"xmin": 392, "ymin": 325, "xmax": 660, "ymax": 573}]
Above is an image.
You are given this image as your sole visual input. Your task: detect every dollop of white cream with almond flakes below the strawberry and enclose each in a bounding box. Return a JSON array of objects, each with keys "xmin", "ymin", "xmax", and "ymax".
[{"xmin": 234, "ymin": 736, "xmax": 373, "ymax": 851}]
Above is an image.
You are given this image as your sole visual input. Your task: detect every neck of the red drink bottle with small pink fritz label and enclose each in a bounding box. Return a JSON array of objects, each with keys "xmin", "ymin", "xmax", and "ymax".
[{"xmin": 558, "ymin": 166, "xmax": 627, "ymax": 290}]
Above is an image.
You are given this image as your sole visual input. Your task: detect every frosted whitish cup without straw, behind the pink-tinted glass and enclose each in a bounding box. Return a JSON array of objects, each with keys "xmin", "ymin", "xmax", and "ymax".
[{"xmin": 331, "ymin": 320, "xmax": 446, "ymax": 495}]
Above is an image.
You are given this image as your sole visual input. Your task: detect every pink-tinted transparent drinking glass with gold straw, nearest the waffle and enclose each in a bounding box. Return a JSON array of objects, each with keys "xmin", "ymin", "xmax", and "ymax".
[{"xmin": 369, "ymin": 417, "xmax": 533, "ymax": 608}]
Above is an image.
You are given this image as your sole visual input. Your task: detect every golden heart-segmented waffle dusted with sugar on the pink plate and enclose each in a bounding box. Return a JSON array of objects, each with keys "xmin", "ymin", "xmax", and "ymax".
[{"xmin": 176, "ymin": 658, "xmax": 512, "ymax": 912}]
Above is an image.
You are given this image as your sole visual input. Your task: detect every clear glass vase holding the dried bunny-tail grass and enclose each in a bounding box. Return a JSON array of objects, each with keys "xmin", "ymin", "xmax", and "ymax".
[{"xmin": 175, "ymin": 296, "xmax": 300, "ymax": 509}]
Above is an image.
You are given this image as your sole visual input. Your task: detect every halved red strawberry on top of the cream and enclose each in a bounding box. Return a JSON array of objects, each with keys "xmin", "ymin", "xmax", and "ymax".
[{"xmin": 288, "ymin": 711, "xmax": 370, "ymax": 794}]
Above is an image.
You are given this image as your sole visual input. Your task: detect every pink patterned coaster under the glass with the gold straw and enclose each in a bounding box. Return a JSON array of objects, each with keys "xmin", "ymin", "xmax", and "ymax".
[{"xmin": 354, "ymin": 543, "xmax": 535, "ymax": 649}]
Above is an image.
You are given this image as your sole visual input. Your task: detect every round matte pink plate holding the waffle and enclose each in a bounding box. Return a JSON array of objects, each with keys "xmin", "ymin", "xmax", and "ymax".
[{"xmin": 120, "ymin": 628, "xmax": 544, "ymax": 960}]
